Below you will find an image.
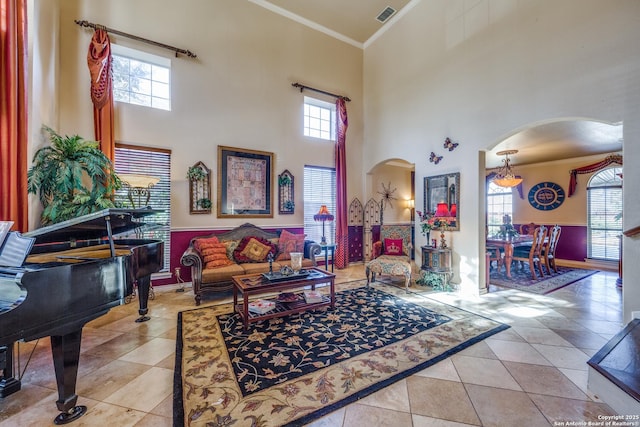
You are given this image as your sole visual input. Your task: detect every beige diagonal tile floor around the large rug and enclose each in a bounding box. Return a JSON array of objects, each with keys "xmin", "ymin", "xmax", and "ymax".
[{"xmin": 0, "ymin": 266, "xmax": 622, "ymax": 427}]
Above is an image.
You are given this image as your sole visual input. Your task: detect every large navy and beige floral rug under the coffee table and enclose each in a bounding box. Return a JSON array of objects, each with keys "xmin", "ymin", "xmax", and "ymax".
[{"xmin": 174, "ymin": 281, "xmax": 508, "ymax": 427}]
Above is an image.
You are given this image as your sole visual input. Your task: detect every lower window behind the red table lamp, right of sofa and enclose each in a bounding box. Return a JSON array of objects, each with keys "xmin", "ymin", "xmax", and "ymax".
[{"xmin": 304, "ymin": 166, "xmax": 336, "ymax": 247}]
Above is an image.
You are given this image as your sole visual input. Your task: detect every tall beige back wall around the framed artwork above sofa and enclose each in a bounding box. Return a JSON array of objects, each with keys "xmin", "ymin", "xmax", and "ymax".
[{"xmin": 33, "ymin": 0, "xmax": 363, "ymax": 230}]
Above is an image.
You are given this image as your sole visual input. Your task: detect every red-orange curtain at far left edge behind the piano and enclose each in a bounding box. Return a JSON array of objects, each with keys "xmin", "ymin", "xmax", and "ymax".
[{"xmin": 0, "ymin": 0, "xmax": 29, "ymax": 232}]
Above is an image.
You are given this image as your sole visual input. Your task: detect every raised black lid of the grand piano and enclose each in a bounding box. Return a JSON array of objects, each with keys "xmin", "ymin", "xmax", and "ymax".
[{"xmin": 23, "ymin": 208, "xmax": 163, "ymax": 245}]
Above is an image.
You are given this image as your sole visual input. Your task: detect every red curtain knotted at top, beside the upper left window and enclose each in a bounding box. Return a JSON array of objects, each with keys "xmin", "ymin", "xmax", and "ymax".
[{"xmin": 87, "ymin": 28, "xmax": 116, "ymax": 162}]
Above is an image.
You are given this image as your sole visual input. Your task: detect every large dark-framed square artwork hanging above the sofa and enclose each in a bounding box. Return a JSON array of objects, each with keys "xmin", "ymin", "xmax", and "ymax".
[{"xmin": 217, "ymin": 145, "xmax": 273, "ymax": 218}]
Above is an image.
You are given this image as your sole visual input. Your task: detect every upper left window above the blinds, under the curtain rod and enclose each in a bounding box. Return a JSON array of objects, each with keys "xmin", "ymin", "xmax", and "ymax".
[{"xmin": 111, "ymin": 45, "xmax": 171, "ymax": 110}]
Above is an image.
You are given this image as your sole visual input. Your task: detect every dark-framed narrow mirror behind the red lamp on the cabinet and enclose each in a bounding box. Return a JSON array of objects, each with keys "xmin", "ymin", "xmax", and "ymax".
[{"xmin": 424, "ymin": 172, "xmax": 460, "ymax": 230}]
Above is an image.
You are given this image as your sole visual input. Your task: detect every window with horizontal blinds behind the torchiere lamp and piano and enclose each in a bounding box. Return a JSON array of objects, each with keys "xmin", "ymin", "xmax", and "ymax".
[{"xmin": 114, "ymin": 144, "xmax": 171, "ymax": 271}]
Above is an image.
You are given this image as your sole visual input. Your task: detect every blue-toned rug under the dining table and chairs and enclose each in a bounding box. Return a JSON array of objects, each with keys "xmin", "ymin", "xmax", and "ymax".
[{"xmin": 489, "ymin": 265, "xmax": 598, "ymax": 295}]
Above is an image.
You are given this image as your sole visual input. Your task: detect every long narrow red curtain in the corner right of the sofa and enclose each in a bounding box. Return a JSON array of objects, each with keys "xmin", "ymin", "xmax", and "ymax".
[{"xmin": 333, "ymin": 98, "xmax": 349, "ymax": 268}]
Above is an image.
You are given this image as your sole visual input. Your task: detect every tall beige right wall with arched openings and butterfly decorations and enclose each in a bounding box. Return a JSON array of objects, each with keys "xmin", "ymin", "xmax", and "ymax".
[{"xmin": 364, "ymin": 0, "xmax": 640, "ymax": 321}]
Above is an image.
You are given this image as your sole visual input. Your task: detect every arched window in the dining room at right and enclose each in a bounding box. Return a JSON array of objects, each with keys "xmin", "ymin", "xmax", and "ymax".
[{"xmin": 587, "ymin": 168, "xmax": 622, "ymax": 261}]
